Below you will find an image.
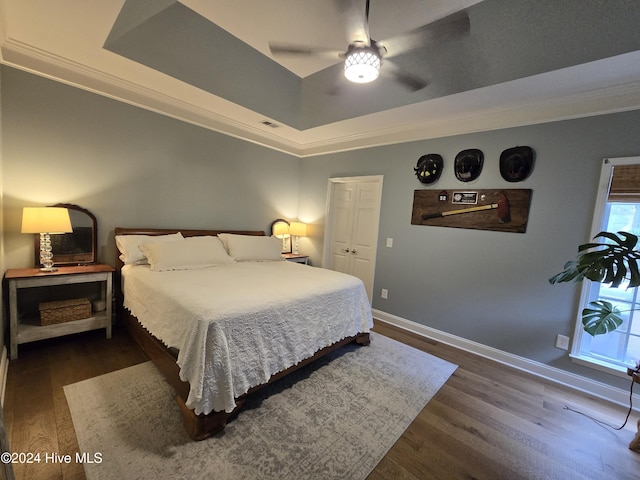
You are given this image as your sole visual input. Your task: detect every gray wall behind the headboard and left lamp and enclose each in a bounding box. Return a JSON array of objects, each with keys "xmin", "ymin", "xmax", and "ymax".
[{"xmin": 2, "ymin": 67, "xmax": 299, "ymax": 268}]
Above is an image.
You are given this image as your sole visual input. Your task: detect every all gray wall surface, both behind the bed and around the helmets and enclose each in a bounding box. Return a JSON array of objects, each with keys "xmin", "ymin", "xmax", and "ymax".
[{"xmin": 1, "ymin": 67, "xmax": 640, "ymax": 394}]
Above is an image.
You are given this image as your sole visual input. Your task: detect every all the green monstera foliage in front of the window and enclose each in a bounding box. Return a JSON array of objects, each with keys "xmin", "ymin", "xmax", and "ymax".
[{"xmin": 549, "ymin": 232, "xmax": 640, "ymax": 336}]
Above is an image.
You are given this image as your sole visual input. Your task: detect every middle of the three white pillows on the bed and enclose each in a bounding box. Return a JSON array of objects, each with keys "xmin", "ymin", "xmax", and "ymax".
[{"xmin": 140, "ymin": 236, "xmax": 234, "ymax": 272}]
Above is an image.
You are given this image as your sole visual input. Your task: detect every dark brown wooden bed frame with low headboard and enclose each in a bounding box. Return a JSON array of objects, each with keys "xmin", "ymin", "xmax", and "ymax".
[{"xmin": 114, "ymin": 227, "xmax": 370, "ymax": 440}]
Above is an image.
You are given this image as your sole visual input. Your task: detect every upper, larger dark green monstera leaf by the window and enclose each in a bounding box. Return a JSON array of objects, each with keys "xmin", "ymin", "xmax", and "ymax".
[{"xmin": 549, "ymin": 232, "xmax": 640, "ymax": 288}]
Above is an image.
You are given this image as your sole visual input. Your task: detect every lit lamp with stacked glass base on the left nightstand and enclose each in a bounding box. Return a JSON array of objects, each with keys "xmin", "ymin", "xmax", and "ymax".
[{"xmin": 20, "ymin": 207, "xmax": 73, "ymax": 272}]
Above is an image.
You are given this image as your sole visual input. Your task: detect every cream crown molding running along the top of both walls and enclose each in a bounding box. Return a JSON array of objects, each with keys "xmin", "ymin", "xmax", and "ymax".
[{"xmin": 1, "ymin": 38, "xmax": 640, "ymax": 157}]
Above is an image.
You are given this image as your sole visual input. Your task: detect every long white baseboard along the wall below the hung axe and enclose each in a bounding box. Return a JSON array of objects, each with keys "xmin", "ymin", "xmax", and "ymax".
[{"xmin": 373, "ymin": 309, "xmax": 640, "ymax": 412}]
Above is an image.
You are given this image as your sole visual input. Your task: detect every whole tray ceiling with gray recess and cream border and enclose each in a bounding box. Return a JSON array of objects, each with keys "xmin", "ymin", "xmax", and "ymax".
[{"xmin": 0, "ymin": 0, "xmax": 640, "ymax": 156}]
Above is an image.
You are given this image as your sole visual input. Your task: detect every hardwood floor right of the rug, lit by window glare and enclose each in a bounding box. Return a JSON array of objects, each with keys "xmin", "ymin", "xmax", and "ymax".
[{"xmin": 369, "ymin": 323, "xmax": 640, "ymax": 480}]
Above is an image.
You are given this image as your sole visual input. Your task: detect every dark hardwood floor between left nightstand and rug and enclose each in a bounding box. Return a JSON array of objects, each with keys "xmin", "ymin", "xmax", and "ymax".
[{"xmin": 4, "ymin": 328, "xmax": 147, "ymax": 480}]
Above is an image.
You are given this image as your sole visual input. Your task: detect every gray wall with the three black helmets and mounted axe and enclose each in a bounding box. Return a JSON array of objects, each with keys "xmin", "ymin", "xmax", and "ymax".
[{"xmin": 299, "ymin": 112, "xmax": 640, "ymax": 388}]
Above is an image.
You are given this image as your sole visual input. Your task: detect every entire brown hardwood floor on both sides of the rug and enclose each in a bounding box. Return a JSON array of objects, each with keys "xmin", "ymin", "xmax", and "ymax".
[{"xmin": 4, "ymin": 323, "xmax": 640, "ymax": 480}]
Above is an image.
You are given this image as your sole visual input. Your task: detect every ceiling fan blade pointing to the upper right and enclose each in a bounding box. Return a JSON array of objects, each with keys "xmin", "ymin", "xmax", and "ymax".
[{"xmin": 378, "ymin": 10, "xmax": 470, "ymax": 57}]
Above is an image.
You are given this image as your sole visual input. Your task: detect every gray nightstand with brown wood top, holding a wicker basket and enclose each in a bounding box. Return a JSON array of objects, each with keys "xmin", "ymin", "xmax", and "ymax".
[{"xmin": 4, "ymin": 265, "xmax": 114, "ymax": 360}]
